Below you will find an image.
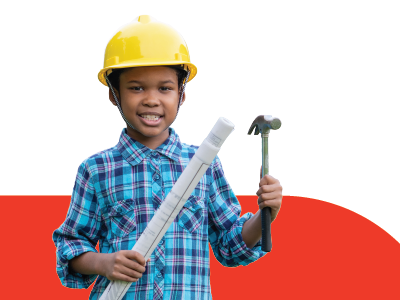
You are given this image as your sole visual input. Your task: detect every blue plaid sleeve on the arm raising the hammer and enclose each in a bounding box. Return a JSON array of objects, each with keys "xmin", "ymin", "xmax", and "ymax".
[{"xmin": 208, "ymin": 156, "xmax": 266, "ymax": 267}]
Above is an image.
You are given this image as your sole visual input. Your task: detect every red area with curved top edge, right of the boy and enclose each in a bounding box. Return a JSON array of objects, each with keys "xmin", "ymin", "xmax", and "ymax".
[{"xmin": 211, "ymin": 196, "xmax": 400, "ymax": 300}]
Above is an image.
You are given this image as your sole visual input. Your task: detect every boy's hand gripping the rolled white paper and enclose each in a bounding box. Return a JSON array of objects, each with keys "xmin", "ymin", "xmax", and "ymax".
[{"xmin": 102, "ymin": 250, "xmax": 150, "ymax": 282}]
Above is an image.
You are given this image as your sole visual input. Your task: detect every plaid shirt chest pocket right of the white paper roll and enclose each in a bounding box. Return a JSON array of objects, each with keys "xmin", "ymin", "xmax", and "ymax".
[{"xmin": 178, "ymin": 195, "xmax": 205, "ymax": 233}]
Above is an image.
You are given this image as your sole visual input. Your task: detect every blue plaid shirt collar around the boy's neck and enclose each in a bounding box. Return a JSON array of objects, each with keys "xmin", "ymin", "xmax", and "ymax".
[{"xmin": 117, "ymin": 128, "xmax": 182, "ymax": 166}]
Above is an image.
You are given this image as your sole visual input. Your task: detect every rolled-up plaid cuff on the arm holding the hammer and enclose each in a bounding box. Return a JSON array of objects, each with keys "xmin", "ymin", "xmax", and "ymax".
[{"xmin": 228, "ymin": 213, "xmax": 267, "ymax": 266}]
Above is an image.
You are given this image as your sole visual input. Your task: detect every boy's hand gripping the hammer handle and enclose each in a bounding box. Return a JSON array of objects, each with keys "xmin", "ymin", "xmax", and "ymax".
[{"xmin": 257, "ymin": 175, "xmax": 282, "ymax": 222}]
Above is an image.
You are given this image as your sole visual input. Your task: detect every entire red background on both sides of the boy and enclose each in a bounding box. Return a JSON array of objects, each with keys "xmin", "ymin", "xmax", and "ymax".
[{"xmin": 0, "ymin": 196, "xmax": 400, "ymax": 300}]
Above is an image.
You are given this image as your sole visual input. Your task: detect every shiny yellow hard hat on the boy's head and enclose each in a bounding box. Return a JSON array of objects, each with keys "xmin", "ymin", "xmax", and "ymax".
[{"xmin": 98, "ymin": 15, "xmax": 197, "ymax": 85}]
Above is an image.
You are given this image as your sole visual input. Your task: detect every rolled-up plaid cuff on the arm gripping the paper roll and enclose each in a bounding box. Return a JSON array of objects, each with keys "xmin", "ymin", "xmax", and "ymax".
[{"xmin": 57, "ymin": 237, "xmax": 97, "ymax": 289}]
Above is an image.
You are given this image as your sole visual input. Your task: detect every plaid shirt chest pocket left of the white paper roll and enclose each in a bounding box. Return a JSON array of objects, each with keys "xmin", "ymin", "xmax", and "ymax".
[{"xmin": 104, "ymin": 199, "xmax": 136, "ymax": 237}]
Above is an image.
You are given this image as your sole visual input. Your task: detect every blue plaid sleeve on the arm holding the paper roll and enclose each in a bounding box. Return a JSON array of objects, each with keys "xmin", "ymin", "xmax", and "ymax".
[{"xmin": 53, "ymin": 163, "xmax": 101, "ymax": 289}]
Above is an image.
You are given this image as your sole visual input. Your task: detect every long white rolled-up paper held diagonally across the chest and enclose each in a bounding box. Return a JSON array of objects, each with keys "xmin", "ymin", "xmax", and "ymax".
[{"xmin": 100, "ymin": 117, "xmax": 235, "ymax": 300}]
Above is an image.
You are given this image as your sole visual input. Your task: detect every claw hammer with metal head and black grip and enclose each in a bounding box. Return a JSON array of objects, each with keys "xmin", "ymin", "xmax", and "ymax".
[{"xmin": 247, "ymin": 115, "xmax": 281, "ymax": 252}]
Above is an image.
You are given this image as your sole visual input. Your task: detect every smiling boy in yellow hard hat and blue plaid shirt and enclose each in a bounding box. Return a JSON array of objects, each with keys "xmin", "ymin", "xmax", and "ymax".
[{"xmin": 53, "ymin": 16, "xmax": 282, "ymax": 299}]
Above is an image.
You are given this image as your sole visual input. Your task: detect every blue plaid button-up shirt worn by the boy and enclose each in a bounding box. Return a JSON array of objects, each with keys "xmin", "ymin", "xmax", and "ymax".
[{"xmin": 53, "ymin": 128, "xmax": 265, "ymax": 299}]
